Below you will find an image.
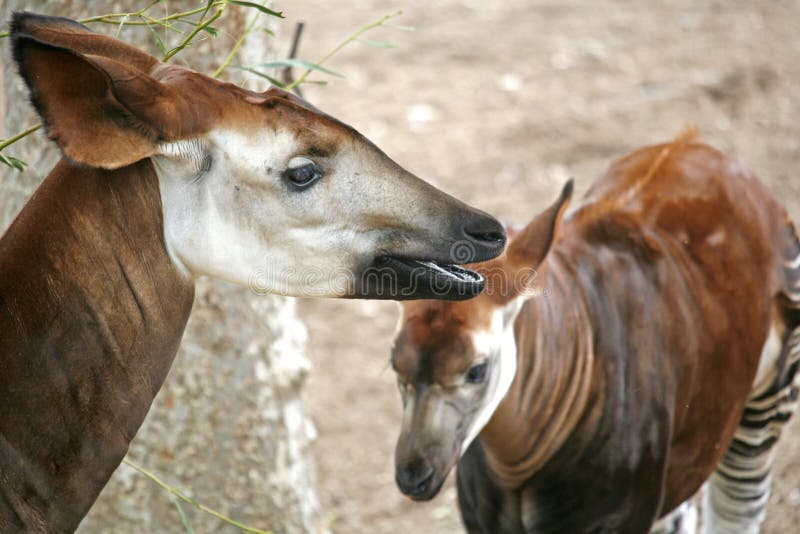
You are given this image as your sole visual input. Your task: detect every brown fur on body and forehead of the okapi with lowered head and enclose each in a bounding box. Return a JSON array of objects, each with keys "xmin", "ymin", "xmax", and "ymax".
[{"xmin": 395, "ymin": 135, "xmax": 800, "ymax": 532}]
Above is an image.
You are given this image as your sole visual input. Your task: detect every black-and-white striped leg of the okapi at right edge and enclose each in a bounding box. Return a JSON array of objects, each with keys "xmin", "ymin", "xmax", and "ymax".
[{"xmin": 702, "ymin": 327, "xmax": 800, "ymax": 534}]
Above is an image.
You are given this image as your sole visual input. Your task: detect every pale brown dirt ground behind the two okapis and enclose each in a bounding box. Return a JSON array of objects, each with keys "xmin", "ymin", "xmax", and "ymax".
[{"xmin": 278, "ymin": 0, "xmax": 800, "ymax": 534}]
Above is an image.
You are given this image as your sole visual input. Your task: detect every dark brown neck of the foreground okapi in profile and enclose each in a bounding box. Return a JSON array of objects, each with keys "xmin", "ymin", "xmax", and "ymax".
[{"xmin": 0, "ymin": 160, "xmax": 194, "ymax": 532}]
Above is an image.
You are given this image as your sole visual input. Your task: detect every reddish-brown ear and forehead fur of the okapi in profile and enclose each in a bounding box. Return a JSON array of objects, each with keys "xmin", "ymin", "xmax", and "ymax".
[{"xmin": 12, "ymin": 14, "xmax": 357, "ymax": 169}]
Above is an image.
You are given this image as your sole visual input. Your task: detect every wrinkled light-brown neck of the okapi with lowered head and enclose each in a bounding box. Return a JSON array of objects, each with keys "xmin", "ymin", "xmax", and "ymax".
[{"xmin": 480, "ymin": 253, "xmax": 599, "ymax": 489}]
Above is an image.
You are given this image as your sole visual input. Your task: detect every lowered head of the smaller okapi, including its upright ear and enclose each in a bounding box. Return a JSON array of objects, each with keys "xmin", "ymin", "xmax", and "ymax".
[{"xmin": 392, "ymin": 181, "xmax": 572, "ymax": 500}]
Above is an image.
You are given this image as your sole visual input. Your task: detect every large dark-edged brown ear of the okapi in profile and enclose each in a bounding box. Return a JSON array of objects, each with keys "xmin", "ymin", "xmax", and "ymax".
[{"xmin": 11, "ymin": 13, "xmax": 193, "ymax": 169}]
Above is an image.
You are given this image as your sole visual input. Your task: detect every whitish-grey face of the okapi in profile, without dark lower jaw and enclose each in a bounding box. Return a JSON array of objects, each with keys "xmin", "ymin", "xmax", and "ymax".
[{"xmin": 153, "ymin": 123, "xmax": 500, "ymax": 297}]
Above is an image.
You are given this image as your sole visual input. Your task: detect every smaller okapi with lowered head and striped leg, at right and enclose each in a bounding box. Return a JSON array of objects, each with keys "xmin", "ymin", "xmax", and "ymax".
[{"xmin": 392, "ymin": 132, "xmax": 800, "ymax": 533}]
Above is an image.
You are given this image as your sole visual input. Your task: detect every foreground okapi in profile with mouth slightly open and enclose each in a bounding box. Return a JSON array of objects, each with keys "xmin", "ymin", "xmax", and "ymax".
[{"xmin": 0, "ymin": 14, "xmax": 505, "ymax": 532}]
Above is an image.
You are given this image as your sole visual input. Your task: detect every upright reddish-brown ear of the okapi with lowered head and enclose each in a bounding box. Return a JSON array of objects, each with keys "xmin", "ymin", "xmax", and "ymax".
[{"xmin": 507, "ymin": 179, "xmax": 573, "ymax": 268}]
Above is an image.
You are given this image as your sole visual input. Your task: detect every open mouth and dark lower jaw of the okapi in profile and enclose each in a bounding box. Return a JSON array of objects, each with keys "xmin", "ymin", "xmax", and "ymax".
[{"xmin": 357, "ymin": 255, "xmax": 484, "ymax": 300}]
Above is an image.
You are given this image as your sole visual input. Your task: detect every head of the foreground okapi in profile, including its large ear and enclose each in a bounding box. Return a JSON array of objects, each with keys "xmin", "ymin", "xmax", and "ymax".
[{"xmin": 11, "ymin": 13, "xmax": 505, "ymax": 299}]
